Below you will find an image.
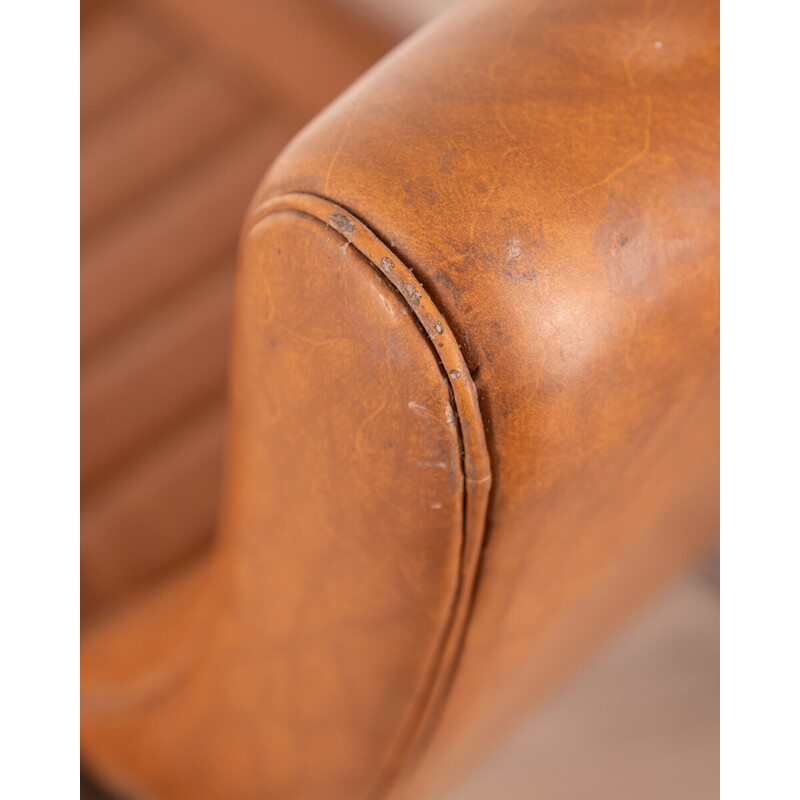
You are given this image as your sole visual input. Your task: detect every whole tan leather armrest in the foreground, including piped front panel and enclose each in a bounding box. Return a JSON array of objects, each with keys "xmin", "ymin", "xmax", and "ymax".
[{"xmin": 79, "ymin": 0, "xmax": 718, "ymax": 798}]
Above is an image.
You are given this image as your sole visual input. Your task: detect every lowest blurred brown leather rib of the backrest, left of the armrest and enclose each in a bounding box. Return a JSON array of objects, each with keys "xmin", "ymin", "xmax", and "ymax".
[{"xmin": 81, "ymin": 406, "xmax": 224, "ymax": 616}]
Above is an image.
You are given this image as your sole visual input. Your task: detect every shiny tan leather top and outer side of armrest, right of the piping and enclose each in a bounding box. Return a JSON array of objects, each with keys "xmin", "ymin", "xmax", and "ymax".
[{"xmin": 256, "ymin": 2, "xmax": 718, "ymax": 796}]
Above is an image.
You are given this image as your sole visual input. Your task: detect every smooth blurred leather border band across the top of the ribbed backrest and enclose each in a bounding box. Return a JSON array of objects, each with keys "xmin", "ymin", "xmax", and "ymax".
[{"xmin": 127, "ymin": 0, "xmax": 397, "ymax": 118}]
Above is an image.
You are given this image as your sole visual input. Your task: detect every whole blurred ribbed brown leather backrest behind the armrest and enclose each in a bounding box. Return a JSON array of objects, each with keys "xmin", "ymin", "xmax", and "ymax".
[{"xmin": 81, "ymin": 0, "xmax": 393, "ymax": 618}]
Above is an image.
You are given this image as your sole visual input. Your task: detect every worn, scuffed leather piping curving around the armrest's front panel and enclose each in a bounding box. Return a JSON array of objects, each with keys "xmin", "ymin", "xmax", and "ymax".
[{"xmin": 244, "ymin": 192, "xmax": 491, "ymax": 797}]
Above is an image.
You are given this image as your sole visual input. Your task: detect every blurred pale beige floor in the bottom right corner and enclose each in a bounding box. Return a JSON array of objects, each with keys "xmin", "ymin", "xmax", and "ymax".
[{"xmin": 434, "ymin": 573, "xmax": 720, "ymax": 800}]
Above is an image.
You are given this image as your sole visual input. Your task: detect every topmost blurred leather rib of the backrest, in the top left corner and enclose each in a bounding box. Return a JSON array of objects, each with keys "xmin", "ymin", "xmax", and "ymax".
[{"xmin": 81, "ymin": 3, "xmax": 174, "ymax": 126}]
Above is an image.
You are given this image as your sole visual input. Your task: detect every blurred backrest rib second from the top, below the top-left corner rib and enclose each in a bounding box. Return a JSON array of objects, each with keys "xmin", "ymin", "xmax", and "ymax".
[{"xmin": 81, "ymin": 58, "xmax": 254, "ymax": 226}]
